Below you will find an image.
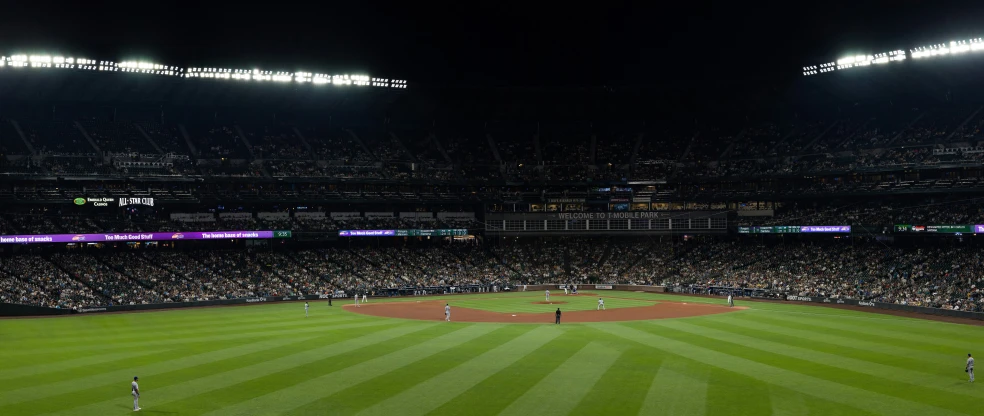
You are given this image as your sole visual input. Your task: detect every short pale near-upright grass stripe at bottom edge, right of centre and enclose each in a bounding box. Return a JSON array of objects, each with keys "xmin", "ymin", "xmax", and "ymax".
[{"xmin": 639, "ymin": 358, "xmax": 708, "ymax": 416}]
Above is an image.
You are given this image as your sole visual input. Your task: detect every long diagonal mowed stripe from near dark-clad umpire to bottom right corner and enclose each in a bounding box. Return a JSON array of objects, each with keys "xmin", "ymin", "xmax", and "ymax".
[{"xmin": 591, "ymin": 324, "xmax": 964, "ymax": 416}]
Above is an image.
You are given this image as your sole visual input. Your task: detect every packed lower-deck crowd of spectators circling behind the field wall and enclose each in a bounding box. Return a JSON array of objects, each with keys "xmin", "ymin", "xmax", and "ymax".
[{"xmin": 0, "ymin": 234, "xmax": 984, "ymax": 311}]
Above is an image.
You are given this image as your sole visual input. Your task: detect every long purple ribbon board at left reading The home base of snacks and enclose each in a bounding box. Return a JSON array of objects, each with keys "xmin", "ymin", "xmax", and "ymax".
[{"xmin": 0, "ymin": 231, "xmax": 273, "ymax": 244}]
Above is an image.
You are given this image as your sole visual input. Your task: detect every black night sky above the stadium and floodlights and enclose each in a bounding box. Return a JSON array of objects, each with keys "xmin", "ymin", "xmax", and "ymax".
[{"xmin": 0, "ymin": 0, "xmax": 984, "ymax": 86}]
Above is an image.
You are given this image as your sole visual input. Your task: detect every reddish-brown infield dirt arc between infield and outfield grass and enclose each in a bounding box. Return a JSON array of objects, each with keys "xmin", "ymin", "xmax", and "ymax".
[{"xmin": 343, "ymin": 301, "xmax": 745, "ymax": 324}]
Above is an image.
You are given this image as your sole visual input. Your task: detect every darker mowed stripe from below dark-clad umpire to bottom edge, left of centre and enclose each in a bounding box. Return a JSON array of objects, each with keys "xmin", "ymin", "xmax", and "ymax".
[{"xmin": 427, "ymin": 331, "xmax": 591, "ymax": 416}]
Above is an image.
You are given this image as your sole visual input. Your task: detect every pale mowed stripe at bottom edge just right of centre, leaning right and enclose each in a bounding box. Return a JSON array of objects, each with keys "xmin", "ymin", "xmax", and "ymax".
[{"xmin": 499, "ymin": 342, "xmax": 621, "ymax": 416}]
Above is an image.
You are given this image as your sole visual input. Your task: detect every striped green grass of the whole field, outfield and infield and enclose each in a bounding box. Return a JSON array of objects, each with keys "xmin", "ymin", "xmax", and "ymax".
[{"xmin": 0, "ymin": 292, "xmax": 984, "ymax": 416}]
